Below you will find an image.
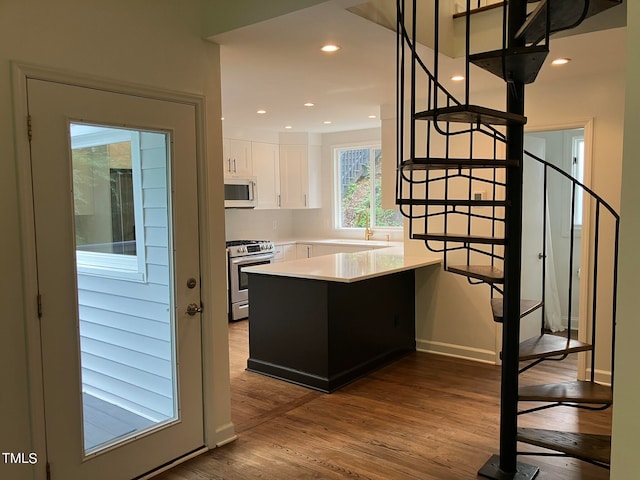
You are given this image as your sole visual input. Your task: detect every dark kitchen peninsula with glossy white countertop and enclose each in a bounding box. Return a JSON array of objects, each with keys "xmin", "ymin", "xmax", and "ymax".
[{"xmin": 243, "ymin": 247, "xmax": 440, "ymax": 393}]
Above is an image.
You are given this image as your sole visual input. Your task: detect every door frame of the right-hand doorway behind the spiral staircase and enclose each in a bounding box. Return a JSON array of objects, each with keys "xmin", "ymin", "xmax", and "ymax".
[{"xmin": 525, "ymin": 118, "xmax": 593, "ymax": 380}]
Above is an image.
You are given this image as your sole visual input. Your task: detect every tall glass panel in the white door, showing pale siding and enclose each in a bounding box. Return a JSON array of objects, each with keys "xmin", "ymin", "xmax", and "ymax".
[{"xmin": 69, "ymin": 123, "xmax": 178, "ymax": 455}]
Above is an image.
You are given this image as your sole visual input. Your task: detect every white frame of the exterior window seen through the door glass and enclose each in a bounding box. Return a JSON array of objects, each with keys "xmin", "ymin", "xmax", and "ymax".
[{"xmin": 69, "ymin": 124, "xmax": 148, "ymax": 283}]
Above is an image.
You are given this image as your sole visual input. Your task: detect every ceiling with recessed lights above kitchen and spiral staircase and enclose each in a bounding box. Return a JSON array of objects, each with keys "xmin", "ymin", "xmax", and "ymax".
[{"xmin": 209, "ymin": 0, "xmax": 625, "ymax": 133}]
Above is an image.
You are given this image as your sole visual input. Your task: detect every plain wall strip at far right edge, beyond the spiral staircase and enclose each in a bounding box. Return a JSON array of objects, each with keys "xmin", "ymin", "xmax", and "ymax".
[{"xmin": 611, "ymin": 2, "xmax": 640, "ymax": 474}]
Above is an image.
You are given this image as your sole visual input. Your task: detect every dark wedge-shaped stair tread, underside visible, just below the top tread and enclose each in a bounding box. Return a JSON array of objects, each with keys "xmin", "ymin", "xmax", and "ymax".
[{"xmin": 469, "ymin": 45, "xmax": 549, "ymax": 84}]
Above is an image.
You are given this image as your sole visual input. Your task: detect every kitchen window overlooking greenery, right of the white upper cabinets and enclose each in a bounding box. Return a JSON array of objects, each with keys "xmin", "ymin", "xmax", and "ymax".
[{"xmin": 335, "ymin": 145, "xmax": 402, "ymax": 228}]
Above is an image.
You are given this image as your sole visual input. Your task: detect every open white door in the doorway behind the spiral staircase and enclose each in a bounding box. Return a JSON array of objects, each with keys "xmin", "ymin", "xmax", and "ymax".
[{"xmin": 520, "ymin": 135, "xmax": 546, "ymax": 341}]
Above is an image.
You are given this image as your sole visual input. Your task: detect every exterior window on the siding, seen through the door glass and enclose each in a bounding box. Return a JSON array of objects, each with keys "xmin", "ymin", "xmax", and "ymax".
[{"xmin": 70, "ymin": 123, "xmax": 149, "ymax": 281}]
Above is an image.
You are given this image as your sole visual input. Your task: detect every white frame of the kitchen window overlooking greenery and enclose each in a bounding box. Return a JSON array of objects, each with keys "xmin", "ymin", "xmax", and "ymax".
[{"xmin": 332, "ymin": 141, "xmax": 403, "ymax": 233}]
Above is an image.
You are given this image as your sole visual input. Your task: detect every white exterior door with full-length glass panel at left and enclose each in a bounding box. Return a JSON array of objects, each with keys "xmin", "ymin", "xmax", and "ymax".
[{"xmin": 27, "ymin": 79, "xmax": 204, "ymax": 480}]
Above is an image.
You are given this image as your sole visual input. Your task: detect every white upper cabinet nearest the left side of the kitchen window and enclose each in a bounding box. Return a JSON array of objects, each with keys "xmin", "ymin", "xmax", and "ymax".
[{"xmin": 280, "ymin": 145, "xmax": 321, "ymax": 208}]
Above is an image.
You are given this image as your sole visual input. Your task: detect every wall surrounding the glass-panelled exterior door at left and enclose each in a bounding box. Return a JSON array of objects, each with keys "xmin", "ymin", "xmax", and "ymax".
[{"xmin": 0, "ymin": 0, "xmax": 230, "ymax": 480}]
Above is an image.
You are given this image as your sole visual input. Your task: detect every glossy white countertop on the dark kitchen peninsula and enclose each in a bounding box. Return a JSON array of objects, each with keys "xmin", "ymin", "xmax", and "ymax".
[{"xmin": 242, "ymin": 247, "xmax": 441, "ymax": 283}]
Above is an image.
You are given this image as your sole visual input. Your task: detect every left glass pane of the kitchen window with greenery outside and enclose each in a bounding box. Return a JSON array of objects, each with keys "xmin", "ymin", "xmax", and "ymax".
[{"xmin": 338, "ymin": 148, "xmax": 371, "ymax": 227}]
